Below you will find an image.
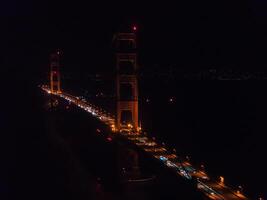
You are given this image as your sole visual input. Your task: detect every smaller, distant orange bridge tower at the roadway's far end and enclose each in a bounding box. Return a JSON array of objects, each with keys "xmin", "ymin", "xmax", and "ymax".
[{"xmin": 50, "ymin": 51, "xmax": 61, "ymax": 93}]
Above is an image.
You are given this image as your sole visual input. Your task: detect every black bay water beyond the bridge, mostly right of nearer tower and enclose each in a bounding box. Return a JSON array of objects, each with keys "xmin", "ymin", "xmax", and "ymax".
[{"xmin": 67, "ymin": 78, "xmax": 267, "ymax": 197}]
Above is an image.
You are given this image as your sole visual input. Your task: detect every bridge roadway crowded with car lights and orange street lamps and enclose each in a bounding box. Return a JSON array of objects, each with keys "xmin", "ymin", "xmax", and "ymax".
[{"xmin": 41, "ymin": 86, "xmax": 248, "ymax": 200}]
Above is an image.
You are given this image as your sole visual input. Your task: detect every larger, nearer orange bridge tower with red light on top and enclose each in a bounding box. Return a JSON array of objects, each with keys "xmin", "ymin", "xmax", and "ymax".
[{"xmin": 115, "ymin": 27, "xmax": 139, "ymax": 132}]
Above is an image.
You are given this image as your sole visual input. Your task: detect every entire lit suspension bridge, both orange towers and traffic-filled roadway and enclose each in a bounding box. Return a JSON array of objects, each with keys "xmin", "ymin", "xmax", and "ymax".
[{"xmin": 41, "ymin": 26, "xmax": 252, "ymax": 200}]
